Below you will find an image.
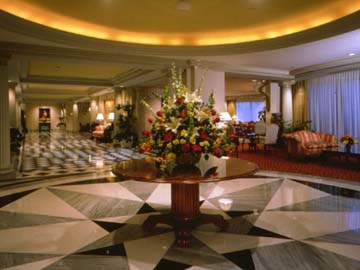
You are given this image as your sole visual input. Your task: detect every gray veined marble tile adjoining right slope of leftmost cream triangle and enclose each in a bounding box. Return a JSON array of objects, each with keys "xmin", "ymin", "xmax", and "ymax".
[{"xmin": 51, "ymin": 189, "xmax": 143, "ymax": 219}]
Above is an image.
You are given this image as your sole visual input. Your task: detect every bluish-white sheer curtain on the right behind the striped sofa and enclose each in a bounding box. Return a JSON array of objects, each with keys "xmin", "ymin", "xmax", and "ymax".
[{"xmin": 308, "ymin": 70, "xmax": 360, "ymax": 139}]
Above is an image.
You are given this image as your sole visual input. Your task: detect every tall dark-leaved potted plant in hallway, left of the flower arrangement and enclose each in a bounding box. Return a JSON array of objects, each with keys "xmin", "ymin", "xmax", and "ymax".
[{"xmin": 115, "ymin": 103, "xmax": 138, "ymax": 147}]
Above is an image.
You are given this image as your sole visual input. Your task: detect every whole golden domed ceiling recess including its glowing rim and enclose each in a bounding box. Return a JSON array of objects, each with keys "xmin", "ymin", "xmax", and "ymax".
[{"xmin": 0, "ymin": 0, "xmax": 360, "ymax": 46}]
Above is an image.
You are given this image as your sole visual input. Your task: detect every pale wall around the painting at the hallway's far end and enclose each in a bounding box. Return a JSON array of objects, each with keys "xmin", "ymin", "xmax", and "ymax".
[{"xmin": 25, "ymin": 103, "xmax": 60, "ymax": 131}]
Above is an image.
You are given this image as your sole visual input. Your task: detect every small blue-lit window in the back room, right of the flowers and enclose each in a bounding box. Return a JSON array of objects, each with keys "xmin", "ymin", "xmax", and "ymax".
[{"xmin": 236, "ymin": 101, "xmax": 265, "ymax": 122}]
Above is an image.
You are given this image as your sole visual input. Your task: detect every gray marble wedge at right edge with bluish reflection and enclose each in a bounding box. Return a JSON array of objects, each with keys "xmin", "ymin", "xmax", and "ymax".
[{"xmin": 273, "ymin": 195, "xmax": 360, "ymax": 212}]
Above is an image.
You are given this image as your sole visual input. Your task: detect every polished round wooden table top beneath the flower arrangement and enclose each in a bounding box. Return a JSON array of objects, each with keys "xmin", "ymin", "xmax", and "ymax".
[{"xmin": 113, "ymin": 157, "xmax": 258, "ymax": 184}]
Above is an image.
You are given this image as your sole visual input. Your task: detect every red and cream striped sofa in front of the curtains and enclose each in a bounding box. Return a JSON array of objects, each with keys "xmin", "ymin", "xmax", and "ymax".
[{"xmin": 283, "ymin": 130, "xmax": 339, "ymax": 157}]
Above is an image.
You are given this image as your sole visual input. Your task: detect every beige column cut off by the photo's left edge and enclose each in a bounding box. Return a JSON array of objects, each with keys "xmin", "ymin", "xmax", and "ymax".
[{"xmin": 0, "ymin": 58, "xmax": 12, "ymax": 174}]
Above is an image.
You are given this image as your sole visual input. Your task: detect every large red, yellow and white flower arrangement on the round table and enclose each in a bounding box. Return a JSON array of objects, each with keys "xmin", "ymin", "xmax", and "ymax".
[{"xmin": 139, "ymin": 67, "xmax": 233, "ymax": 170}]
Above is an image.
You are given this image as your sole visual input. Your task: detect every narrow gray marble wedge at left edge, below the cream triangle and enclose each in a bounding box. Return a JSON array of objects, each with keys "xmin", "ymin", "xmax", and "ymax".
[{"xmin": 0, "ymin": 211, "xmax": 80, "ymax": 230}]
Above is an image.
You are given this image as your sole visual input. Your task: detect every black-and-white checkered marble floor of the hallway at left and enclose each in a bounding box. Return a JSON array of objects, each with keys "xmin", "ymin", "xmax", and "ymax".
[{"xmin": 17, "ymin": 131, "xmax": 143, "ymax": 179}]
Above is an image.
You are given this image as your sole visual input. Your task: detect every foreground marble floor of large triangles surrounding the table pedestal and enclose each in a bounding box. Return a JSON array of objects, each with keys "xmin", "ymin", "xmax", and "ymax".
[{"xmin": 0, "ymin": 173, "xmax": 360, "ymax": 270}]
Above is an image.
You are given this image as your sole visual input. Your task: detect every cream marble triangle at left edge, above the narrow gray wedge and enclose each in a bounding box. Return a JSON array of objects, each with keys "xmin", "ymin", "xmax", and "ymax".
[{"xmin": 1, "ymin": 189, "xmax": 87, "ymax": 219}]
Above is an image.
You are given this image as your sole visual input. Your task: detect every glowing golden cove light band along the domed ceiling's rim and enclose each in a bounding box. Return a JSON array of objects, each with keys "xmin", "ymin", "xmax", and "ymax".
[{"xmin": 0, "ymin": 0, "xmax": 360, "ymax": 46}]
